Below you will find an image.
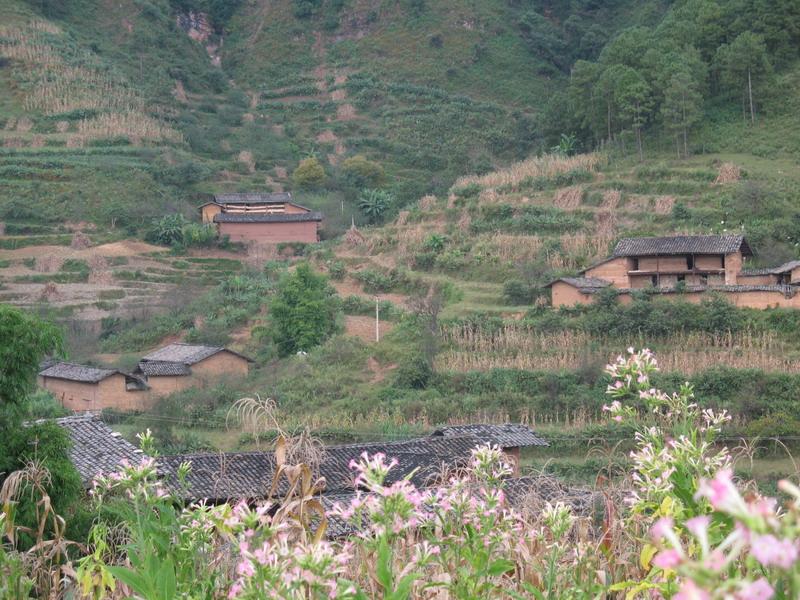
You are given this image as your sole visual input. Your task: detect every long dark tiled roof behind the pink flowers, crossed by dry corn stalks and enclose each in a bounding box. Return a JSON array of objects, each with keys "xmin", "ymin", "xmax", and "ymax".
[{"xmin": 158, "ymin": 435, "xmax": 485, "ymax": 501}]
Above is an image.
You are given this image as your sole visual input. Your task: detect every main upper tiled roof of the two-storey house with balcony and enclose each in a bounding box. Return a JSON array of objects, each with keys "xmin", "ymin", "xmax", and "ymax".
[{"xmin": 613, "ymin": 235, "xmax": 753, "ymax": 257}]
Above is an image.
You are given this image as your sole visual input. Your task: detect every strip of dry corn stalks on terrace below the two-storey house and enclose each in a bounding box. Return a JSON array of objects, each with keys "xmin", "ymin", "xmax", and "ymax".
[{"xmin": 437, "ymin": 324, "xmax": 800, "ymax": 375}]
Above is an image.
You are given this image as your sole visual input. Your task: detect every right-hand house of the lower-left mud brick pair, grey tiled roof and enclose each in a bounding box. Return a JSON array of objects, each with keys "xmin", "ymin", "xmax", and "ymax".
[{"xmin": 134, "ymin": 343, "xmax": 253, "ymax": 396}]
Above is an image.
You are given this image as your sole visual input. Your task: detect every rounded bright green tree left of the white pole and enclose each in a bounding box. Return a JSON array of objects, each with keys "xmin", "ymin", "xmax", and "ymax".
[{"xmin": 269, "ymin": 263, "xmax": 339, "ymax": 356}]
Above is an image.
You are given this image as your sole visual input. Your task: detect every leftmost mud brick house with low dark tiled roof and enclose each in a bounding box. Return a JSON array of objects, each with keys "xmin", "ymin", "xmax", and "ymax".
[{"xmin": 39, "ymin": 362, "xmax": 150, "ymax": 411}]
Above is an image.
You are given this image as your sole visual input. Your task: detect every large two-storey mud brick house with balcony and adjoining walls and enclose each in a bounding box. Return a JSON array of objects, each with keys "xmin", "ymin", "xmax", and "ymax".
[{"xmin": 548, "ymin": 235, "xmax": 800, "ymax": 308}]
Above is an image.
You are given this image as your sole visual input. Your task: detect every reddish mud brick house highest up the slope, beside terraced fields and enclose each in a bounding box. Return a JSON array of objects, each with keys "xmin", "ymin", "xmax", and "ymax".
[{"xmin": 200, "ymin": 192, "xmax": 322, "ymax": 244}]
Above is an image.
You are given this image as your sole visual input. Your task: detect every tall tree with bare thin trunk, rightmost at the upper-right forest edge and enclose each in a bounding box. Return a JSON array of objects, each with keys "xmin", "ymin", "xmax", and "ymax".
[{"xmin": 715, "ymin": 31, "xmax": 772, "ymax": 123}]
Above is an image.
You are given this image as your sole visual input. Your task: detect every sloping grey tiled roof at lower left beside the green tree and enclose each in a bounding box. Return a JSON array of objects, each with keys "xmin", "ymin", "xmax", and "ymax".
[{"xmin": 41, "ymin": 415, "xmax": 145, "ymax": 487}]
